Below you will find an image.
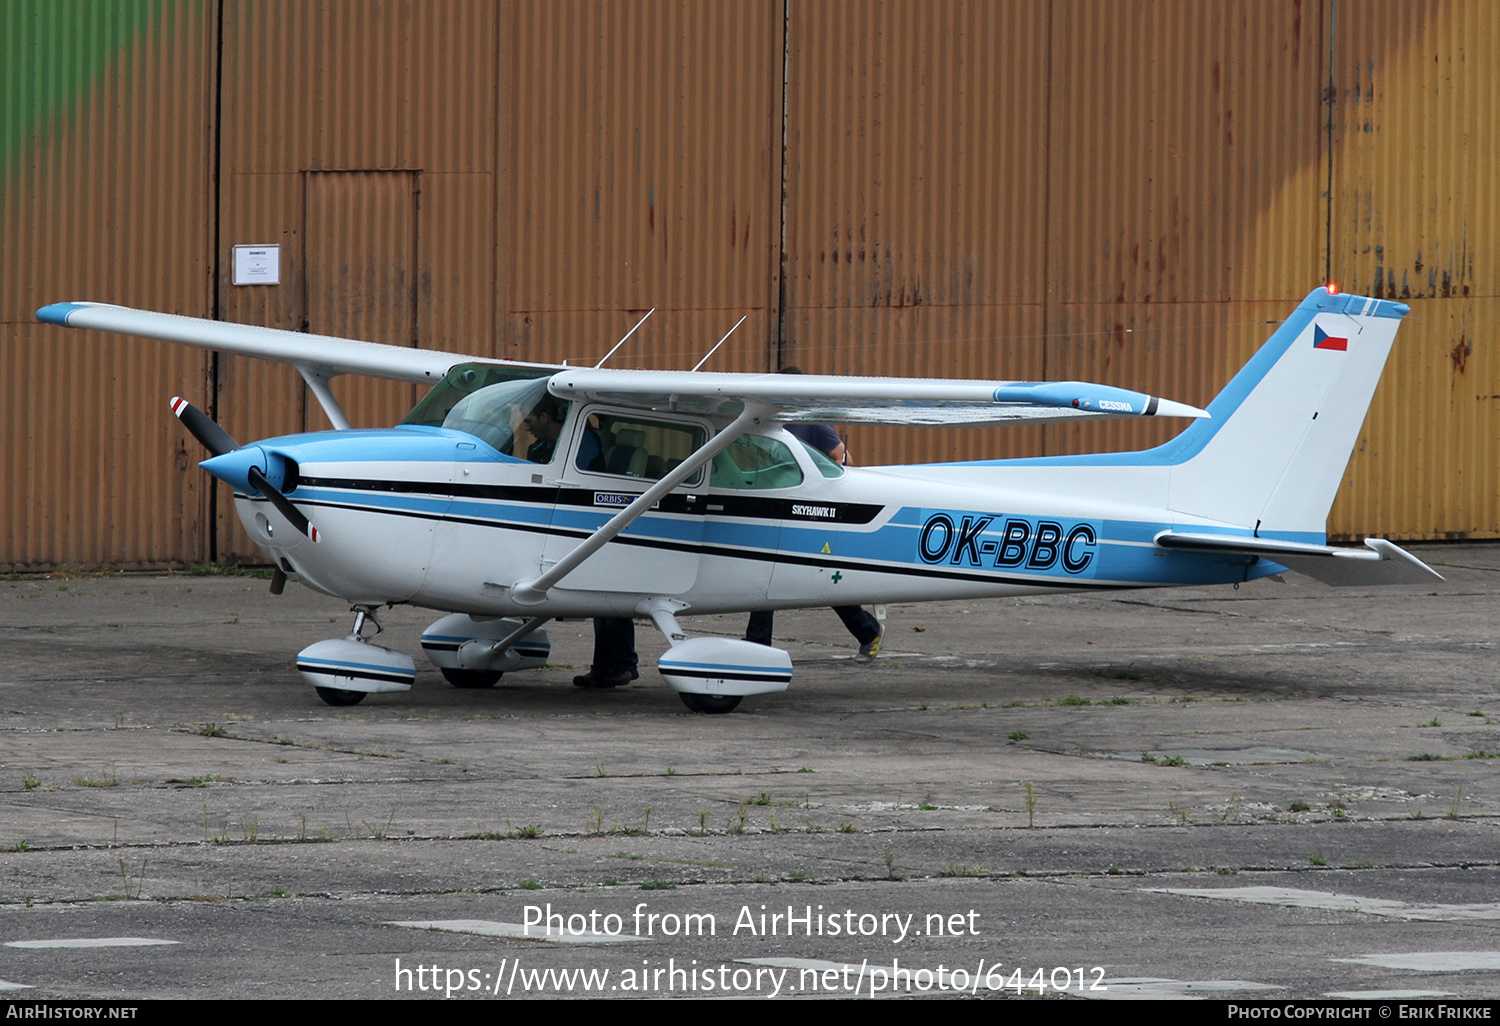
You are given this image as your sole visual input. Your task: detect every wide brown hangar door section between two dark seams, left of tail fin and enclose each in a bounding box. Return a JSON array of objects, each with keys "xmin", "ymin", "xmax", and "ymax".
[{"xmin": 786, "ymin": 0, "xmax": 1328, "ymax": 474}]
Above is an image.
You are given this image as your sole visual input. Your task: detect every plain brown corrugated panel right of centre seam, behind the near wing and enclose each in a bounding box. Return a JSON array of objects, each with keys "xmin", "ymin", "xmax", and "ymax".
[{"xmin": 782, "ymin": 2, "xmax": 1049, "ymax": 465}]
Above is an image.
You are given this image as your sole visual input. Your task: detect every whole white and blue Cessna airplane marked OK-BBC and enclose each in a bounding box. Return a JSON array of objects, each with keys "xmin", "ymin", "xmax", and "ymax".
[{"xmin": 38, "ymin": 288, "xmax": 1440, "ymax": 713}]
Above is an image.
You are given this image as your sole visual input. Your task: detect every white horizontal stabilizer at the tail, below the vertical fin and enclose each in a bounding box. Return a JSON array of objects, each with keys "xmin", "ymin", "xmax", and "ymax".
[{"xmin": 1157, "ymin": 531, "xmax": 1443, "ymax": 588}]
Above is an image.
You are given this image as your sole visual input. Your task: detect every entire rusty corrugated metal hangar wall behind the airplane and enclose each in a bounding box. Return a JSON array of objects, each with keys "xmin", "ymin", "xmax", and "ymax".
[{"xmin": 0, "ymin": 0, "xmax": 1500, "ymax": 569}]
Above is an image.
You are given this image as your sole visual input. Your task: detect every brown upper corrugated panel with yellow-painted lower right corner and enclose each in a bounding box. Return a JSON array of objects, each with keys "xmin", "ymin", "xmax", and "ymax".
[{"xmin": 1046, "ymin": 0, "xmax": 1326, "ymax": 303}]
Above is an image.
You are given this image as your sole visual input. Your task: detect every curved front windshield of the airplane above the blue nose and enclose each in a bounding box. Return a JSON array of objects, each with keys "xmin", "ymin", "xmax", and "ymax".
[{"xmin": 401, "ymin": 363, "xmax": 569, "ymax": 462}]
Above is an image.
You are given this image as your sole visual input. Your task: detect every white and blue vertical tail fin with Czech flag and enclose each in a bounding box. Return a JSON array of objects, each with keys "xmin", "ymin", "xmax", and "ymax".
[{"xmin": 1154, "ymin": 288, "xmax": 1410, "ymax": 539}]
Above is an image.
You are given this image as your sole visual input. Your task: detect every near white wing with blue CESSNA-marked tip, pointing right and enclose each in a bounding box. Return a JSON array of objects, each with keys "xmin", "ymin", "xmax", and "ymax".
[{"xmin": 549, "ymin": 368, "xmax": 1209, "ymax": 428}]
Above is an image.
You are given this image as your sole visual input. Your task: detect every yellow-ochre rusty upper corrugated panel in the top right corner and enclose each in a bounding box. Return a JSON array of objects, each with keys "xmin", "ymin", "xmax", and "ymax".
[{"xmin": 1332, "ymin": 0, "xmax": 1500, "ymax": 300}]
